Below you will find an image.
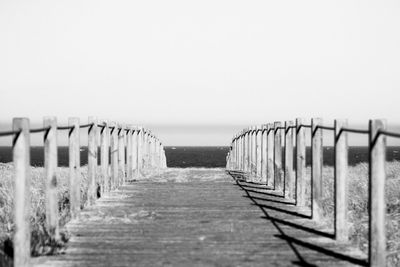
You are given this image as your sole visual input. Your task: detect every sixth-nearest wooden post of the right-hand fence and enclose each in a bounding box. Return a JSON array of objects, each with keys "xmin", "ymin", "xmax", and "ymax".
[{"xmin": 274, "ymin": 121, "xmax": 283, "ymax": 192}]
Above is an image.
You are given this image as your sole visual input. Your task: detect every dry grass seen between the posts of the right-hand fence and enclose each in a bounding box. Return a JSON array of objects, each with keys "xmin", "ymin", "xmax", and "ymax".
[{"xmin": 307, "ymin": 162, "xmax": 400, "ymax": 266}]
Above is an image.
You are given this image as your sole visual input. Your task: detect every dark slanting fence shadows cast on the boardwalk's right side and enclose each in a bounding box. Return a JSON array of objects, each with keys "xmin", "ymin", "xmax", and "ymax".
[{"xmin": 228, "ymin": 172, "xmax": 368, "ymax": 266}]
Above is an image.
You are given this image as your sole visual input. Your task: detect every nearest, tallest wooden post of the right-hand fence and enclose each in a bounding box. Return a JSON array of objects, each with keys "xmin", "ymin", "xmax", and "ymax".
[{"xmin": 369, "ymin": 120, "xmax": 386, "ymax": 267}]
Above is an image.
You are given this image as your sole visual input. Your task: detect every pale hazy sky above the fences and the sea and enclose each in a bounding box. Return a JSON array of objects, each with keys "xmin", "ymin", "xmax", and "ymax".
[{"xmin": 0, "ymin": 0, "xmax": 400, "ymax": 145}]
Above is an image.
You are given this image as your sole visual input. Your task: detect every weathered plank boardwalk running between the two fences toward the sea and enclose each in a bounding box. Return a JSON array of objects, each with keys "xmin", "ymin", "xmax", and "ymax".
[{"xmin": 34, "ymin": 169, "xmax": 364, "ymax": 266}]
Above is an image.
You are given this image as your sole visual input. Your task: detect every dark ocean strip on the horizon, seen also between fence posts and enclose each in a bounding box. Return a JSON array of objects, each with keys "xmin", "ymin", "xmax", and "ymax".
[{"xmin": 0, "ymin": 146, "xmax": 400, "ymax": 168}]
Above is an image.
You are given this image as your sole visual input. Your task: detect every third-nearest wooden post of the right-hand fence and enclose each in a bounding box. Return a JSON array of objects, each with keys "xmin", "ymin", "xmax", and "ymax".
[{"xmin": 311, "ymin": 118, "xmax": 323, "ymax": 221}]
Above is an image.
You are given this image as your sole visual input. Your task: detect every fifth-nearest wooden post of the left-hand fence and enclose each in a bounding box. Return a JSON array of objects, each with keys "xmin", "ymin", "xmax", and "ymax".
[{"xmin": 100, "ymin": 121, "xmax": 109, "ymax": 194}]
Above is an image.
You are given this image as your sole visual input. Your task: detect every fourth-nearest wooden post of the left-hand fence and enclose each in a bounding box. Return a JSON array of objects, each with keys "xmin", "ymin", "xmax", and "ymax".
[{"xmin": 88, "ymin": 117, "xmax": 99, "ymax": 205}]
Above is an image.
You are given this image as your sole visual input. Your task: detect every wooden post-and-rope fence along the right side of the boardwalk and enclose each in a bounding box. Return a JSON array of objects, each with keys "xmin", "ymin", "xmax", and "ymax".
[{"xmin": 227, "ymin": 118, "xmax": 400, "ymax": 266}]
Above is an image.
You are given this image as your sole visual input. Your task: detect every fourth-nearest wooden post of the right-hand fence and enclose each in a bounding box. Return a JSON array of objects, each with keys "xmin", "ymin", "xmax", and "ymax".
[{"xmin": 296, "ymin": 118, "xmax": 306, "ymax": 206}]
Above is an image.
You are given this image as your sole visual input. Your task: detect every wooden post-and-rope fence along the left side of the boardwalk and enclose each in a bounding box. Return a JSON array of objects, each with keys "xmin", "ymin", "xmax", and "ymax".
[{"xmin": 0, "ymin": 117, "xmax": 167, "ymax": 266}]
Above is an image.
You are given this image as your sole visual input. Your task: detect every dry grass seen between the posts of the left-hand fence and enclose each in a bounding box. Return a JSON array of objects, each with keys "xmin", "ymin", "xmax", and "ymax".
[{"xmin": 0, "ymin": 163, "xmax": 87, "ymax": 265}]
